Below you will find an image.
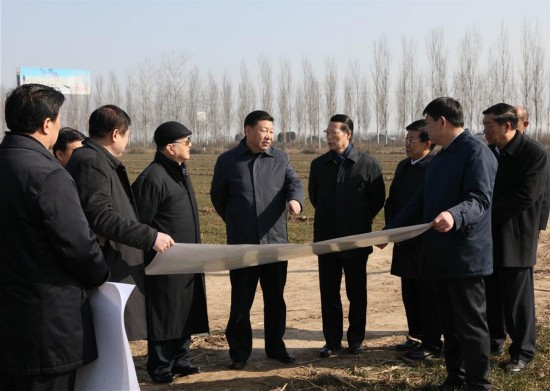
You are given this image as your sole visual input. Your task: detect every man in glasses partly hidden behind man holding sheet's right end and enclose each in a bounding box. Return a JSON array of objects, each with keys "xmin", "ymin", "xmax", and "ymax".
[{"xmin": 384, "ymin": 119, "xmax": 442, "ymax": 360}]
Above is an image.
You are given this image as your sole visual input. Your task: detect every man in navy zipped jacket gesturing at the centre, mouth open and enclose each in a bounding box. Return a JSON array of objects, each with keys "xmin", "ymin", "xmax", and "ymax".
[{"xmin": 210, "ymin": 110, "xmax": 304, "ymax": 369}]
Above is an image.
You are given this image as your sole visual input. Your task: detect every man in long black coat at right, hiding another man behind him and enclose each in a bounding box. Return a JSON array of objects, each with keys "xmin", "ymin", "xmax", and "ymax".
[{"xmin": 483, "ymin": 103, "xmax": 548, "ymax": 373}]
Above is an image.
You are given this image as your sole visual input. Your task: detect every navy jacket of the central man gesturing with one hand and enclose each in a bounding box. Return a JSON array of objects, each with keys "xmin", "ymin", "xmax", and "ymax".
[{"xmin": 210, "ymin": 138, "xmax": 304, "ymax": 244}]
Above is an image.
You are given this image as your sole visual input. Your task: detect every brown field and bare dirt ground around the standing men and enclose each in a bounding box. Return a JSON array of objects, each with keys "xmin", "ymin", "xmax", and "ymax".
[{"xmin": 123, "ymin": 147, "xmax": 550, "ymax": 391}]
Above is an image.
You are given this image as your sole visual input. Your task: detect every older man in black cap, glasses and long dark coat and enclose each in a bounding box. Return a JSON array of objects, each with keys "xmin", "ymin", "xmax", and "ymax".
[{"xmin": 132, "ymin": 121, "xmax": 208, "ymax": 383}]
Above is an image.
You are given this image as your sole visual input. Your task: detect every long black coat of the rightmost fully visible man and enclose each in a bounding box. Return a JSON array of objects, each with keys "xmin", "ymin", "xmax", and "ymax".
[{"xmin": 490, "ymin": 132, "xmax": 548, "ymax": 267}]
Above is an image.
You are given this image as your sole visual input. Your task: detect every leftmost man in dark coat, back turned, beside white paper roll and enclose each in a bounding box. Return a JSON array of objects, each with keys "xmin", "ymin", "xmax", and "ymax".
[{"xmin": 0, "ymin": 84, "xmax": 109, "ymax": 391}]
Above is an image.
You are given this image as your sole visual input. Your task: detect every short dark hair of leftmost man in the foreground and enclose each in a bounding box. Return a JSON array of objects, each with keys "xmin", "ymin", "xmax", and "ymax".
[{"xmin": 4, "ymin": 84, "xmax": 65, "ymax": 133}]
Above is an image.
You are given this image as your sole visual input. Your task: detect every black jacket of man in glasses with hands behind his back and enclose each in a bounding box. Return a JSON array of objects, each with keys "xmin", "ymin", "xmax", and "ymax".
[{"xmin": 308, "ymin": 147, "xmax": 386, "ymax": 258}]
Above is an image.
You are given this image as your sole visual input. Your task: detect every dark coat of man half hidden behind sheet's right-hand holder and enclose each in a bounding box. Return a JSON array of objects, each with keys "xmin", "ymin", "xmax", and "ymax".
[{"xmin": 384, "ymin": 153, "xmax": 433, "ymax": 278}]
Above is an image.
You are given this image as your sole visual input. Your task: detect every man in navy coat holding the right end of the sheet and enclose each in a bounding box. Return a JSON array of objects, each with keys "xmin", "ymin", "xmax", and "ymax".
[{"xmin": 386, "ymin": 97, "xmax": 497, "ymax": 390}]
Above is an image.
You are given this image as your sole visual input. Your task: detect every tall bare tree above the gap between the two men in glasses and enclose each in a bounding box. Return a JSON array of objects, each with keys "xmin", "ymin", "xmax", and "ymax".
[{"xmin": 372, "ymin": 36, "xmax": 391, "ymax": 143}]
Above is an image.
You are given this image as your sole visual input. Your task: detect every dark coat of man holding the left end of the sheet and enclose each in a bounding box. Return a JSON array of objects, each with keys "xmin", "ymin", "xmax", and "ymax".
[{"xmin": 67, "ymin": 139, "xmax": 157, "ymax": 341}]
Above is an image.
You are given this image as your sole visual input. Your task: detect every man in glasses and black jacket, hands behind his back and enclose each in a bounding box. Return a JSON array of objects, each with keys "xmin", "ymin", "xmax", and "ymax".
[{"xmin": 309, "ymin": 114, "xmax": 386, "ymax": 358}]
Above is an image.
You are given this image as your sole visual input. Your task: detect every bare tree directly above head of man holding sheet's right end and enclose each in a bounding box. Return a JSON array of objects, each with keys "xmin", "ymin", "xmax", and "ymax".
[{"xmin": 426, "ymin": 28, "xmax": 447, "ymax": 99}]
